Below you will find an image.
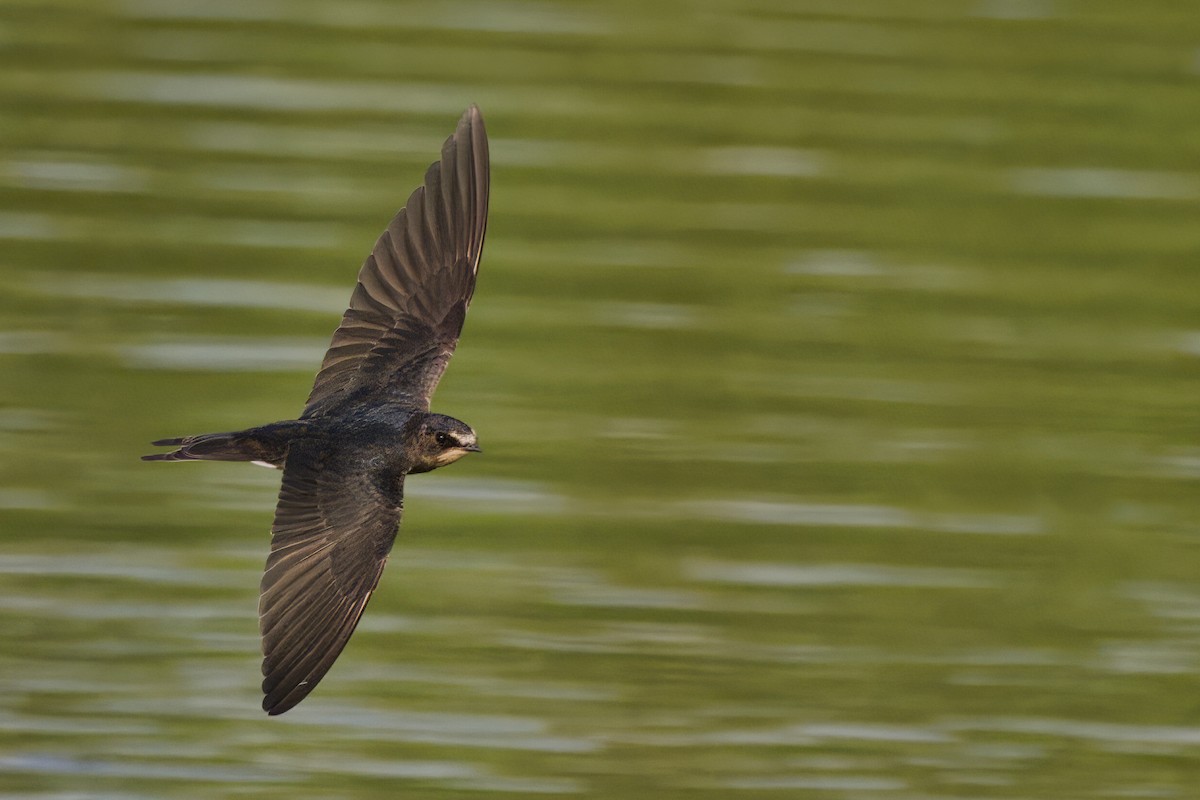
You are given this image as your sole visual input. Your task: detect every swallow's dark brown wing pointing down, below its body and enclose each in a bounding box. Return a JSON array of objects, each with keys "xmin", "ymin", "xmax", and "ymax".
[{"xmin": 258, "ymin": 443, "xmax": 403, "ymax": 715}]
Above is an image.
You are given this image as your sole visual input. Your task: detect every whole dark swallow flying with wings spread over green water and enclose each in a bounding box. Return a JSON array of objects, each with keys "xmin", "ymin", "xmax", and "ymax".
[{"xmin": 142, "ymin": 106, "xmax": 488, "ymax": 715}]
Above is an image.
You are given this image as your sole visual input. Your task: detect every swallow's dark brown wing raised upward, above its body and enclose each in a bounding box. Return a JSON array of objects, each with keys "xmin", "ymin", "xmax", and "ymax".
[{"xmin": 301, "ymin": 106, "xmax": 490, "ymax": 417}]
